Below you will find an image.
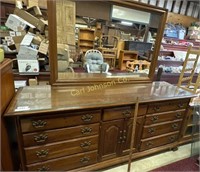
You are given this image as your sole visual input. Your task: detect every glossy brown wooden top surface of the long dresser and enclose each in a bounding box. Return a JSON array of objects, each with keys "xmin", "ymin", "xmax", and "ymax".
[{"xmin": 5, "ymin": 79, "xmax": 194, "ymax": 116}]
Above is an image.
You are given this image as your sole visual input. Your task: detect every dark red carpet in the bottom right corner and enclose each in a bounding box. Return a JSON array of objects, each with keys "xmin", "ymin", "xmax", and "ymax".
[{"xmin": 151, "ymin": 156, "xmax": 200, "ymax": 172}]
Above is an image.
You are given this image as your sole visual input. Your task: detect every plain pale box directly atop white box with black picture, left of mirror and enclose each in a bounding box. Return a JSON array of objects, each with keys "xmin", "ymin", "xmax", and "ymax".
[{"xmin": 17, "ymin": 45, "xmax": 38, "ymax": 60}]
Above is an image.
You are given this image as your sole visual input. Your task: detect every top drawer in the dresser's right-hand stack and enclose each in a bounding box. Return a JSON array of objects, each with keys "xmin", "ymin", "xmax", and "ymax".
[{"xmin": 147, "ymin": 100, "xmax": 189, "ymax": 113}]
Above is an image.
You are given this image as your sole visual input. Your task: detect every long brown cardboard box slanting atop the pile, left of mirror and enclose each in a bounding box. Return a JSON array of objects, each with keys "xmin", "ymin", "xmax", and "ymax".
[{"xmin": 14, "ymin": 8, "xmax": 48, "ymax": 33}]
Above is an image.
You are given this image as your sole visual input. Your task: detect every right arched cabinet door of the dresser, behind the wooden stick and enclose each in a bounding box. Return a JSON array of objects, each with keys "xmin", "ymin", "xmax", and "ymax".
[{"xmin": 121, "ymin": 116, "xmax": 144, "ymax": 155}]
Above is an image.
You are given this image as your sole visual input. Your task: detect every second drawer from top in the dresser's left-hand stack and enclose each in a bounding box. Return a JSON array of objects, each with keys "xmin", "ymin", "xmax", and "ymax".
[{"xmin": 23, "ymin": 123, "xmax": 99, "ymax": 147}]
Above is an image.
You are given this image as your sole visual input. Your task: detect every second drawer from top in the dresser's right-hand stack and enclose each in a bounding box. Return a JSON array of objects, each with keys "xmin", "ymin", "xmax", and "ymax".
[{"xmin": 145, "ymin": 110, "xmax": 185, "ymax": 125}]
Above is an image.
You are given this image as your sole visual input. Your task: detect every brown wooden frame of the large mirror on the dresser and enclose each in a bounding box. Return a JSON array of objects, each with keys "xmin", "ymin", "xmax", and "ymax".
[{"xmin": 47, "ymin": 0, "xmax": 168, "ymax": 86}]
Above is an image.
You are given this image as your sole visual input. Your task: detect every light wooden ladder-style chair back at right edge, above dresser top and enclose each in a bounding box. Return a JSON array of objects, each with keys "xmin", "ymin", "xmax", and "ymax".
[{"xmin": 178, "ymin": 46, "xmax": 200, "ymax": 93}]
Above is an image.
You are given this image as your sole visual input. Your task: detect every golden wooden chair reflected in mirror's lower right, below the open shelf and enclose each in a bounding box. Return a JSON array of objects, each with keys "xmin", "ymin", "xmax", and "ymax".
[{"xmin": 126, "ymin": 60, "xmax": 151, "ymax": 72}]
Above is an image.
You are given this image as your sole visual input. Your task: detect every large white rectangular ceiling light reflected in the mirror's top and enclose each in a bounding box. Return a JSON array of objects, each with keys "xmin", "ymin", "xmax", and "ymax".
[{"xmin": 112, "ymin": 5, "xmax": 151, "ymax": 24}]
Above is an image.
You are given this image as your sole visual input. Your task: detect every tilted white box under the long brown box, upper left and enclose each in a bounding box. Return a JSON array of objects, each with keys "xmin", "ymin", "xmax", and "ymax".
[{"xmin": 5, "ymin": 14, "xmax": 35, "ymax": 32}]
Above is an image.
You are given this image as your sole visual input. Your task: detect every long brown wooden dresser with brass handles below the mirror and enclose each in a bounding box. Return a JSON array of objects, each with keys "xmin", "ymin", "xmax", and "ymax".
[{"xmin": 5, "ymin": 82, "xmax": 194, "ymax": 171}]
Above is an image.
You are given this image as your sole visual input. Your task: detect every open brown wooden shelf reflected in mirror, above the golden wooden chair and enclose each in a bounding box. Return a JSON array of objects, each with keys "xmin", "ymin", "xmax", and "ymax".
[{"xmin": 119, "ymin": 50, "xmax": 138, "ymax": 70}]
